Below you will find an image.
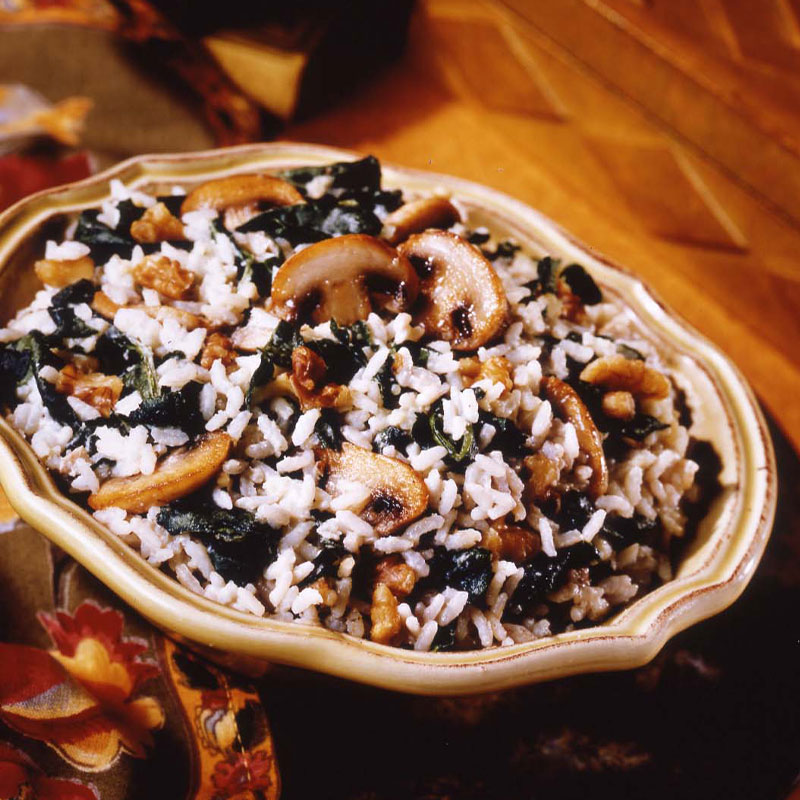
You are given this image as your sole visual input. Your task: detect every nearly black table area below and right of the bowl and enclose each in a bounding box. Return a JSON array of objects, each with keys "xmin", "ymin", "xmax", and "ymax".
[{"xmin": 263, "ymin": 416, "xmax": 800, "ymax": 800}]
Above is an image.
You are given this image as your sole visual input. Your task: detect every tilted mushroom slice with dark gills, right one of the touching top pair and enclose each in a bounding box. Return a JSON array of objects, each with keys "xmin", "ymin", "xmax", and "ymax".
[{"xmin": 397, "ymin": 231, "xmax": 508, "ymax": 350}]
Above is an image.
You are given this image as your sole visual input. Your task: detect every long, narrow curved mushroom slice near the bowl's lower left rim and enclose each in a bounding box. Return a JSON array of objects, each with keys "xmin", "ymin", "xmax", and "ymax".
[{"xmin": 89, "ymin": 432, "xmax": 232, "ymax": 514}]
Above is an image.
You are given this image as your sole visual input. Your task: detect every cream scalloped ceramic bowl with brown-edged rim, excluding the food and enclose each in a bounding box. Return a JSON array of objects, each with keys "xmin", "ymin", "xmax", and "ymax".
[{"xmin": 0, "ymin": 143, "xmax": 776, "ymax": 694}]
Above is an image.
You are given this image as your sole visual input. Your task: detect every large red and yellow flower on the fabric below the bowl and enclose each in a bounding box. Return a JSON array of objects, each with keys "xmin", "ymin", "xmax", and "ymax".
[{"xmin": 0, "ymin": 602, "xmax": 164, "ymax": 770}]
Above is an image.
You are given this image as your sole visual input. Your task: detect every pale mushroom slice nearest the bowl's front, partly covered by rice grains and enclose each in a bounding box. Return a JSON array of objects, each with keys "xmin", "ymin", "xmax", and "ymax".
[{"xmin": 318, "ymin": 442, "xmax": 428, "ymax": 536}]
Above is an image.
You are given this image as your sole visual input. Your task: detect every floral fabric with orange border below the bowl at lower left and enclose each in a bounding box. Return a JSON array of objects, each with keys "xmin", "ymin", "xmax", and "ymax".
[{"xmin": 0, "ymin": 523, "xmax": 280, "ymax": 800}]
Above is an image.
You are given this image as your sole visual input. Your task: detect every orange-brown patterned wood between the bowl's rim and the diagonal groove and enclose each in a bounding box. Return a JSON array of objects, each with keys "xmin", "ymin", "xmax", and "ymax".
[{"xmin": 284, "ymin": 0, "xmax": 800, "ymax": 450}]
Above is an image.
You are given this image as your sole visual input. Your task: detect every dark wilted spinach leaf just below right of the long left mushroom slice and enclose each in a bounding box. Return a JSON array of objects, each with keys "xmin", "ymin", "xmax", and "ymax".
[{"xmin": 156, "ymin": 502, "xmax": 278, "ymax": 584}]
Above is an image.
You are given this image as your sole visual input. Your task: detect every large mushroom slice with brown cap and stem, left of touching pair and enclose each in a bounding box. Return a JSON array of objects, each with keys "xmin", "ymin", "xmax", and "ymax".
[{"xmin": 272, "ymin": 233, "xmax": 418, "ymax": 325}]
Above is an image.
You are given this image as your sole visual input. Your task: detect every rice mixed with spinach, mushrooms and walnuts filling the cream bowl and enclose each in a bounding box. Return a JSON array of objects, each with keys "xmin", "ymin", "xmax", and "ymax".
[{"xmin": 0, "ymin": 158, "xmax": 712, "ymax": 650}]
